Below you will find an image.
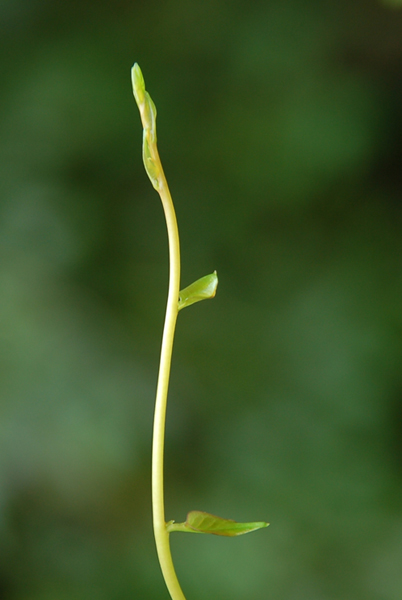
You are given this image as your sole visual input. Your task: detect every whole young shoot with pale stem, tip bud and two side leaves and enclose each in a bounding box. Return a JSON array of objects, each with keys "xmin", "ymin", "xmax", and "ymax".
[{"xmin": 131, "ymin": 63, "xmax": 268, "ymax": 600}]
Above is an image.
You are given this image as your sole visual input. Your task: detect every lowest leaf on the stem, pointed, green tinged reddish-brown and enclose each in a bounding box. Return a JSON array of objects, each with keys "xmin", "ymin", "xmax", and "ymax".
[{"xmin": 166, "ymin": 510, "xmax": 269, "ymax": 537}]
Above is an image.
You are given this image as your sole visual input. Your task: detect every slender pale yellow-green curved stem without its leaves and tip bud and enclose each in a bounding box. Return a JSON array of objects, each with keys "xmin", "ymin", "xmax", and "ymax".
[{"xmin": 152, "ymin": 151, "xmax": 185, "ymax": 600}]
